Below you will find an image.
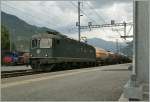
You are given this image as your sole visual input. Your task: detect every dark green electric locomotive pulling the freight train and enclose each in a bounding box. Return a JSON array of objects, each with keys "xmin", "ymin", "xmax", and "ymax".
[{"xmin": 30, "ymin": 32, "xmax": 96, "ymax": 71}]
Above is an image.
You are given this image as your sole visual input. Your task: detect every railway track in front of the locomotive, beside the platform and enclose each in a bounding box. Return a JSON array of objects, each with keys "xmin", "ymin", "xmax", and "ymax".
[{"xmin": 1, "ymin": 69, "xmax": 41, "ymax": 78}]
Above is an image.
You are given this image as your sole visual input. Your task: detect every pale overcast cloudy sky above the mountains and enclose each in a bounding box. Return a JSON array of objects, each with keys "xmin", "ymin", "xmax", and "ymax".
[{"xmin": 1, "ymin": 0, "xmax": 133, "ymax": 41}]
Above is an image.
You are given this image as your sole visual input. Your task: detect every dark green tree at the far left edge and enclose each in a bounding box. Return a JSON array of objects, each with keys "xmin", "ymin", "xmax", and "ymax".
[{"xmin": 1, "ymin": 25, "xmax": 10, "ymax": 50}]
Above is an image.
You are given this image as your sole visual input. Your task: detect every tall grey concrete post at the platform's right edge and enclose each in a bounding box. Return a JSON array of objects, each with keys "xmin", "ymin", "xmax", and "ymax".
[{"xmin": 124, "ymin": 1, "xmax": 150, "ymax": 100}]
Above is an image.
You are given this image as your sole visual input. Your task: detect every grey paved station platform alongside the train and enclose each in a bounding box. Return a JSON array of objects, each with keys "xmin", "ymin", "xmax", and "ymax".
[{"xmin": 1, "ymin": 64, "xmax": 131, "ymax": 101}]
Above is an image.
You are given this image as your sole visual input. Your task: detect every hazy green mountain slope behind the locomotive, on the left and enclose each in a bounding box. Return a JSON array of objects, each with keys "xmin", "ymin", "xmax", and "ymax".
[{"xmin": 1, "ymin": 12, "xmax": 57, "ymax": 51}]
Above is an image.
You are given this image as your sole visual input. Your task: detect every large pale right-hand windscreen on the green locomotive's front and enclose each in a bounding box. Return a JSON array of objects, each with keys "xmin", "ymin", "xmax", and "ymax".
[{"xmin": 40, "ymin": 38, "xmax": 52, "ymax": 48}]
